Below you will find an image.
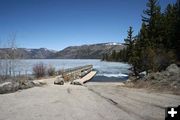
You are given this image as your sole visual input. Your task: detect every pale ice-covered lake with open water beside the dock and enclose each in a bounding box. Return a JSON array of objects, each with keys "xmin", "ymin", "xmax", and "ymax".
[{"xmin": 18, "ymin": 59, "xmax": 130, "ymax": 82}]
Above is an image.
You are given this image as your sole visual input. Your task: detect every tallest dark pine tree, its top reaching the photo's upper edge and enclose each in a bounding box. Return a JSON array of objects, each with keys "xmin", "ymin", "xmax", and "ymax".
[{"xmin": 142, "ymin": 0, "xmax": 162, "ymax": 47}]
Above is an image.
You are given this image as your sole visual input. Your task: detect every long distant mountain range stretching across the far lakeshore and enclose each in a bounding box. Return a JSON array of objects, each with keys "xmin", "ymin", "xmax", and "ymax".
[{"xmin": 0, "ymin": 42, "xmax": 125, "ymax": 59}]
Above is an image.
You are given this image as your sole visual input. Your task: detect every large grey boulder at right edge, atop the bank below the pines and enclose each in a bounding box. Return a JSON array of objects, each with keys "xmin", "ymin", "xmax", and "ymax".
[{"xmin": 166, "ymin": 64, "xmax": 180, "ymax": 75}]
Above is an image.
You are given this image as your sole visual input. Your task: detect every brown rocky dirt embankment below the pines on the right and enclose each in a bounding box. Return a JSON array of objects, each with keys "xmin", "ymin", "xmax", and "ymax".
[{"xmin": 125, "ymin": 64, "xmax": 180, "ymax": 95}]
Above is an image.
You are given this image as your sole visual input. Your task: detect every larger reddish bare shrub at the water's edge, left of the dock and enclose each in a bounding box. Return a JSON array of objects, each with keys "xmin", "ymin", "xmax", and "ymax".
[{"xmin": 33, "ymin": 63, "xmax": 46, "ymax": 78}]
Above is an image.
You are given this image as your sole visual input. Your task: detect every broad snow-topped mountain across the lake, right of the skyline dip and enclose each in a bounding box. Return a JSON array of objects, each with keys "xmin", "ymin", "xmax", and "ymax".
[{"xmin": 55, "ymin": 42, "xmax": 125, "ymax": 59}]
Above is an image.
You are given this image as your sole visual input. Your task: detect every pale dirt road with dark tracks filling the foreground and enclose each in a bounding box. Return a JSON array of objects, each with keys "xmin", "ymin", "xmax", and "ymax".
[{"xmin": 0, "ymin": 81, "xmax": 180, "ymax": 120}]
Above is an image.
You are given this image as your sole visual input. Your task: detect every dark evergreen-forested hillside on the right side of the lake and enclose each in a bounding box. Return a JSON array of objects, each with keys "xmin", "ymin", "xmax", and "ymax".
[{"xmin": 102, "ymin": 0, "xmax": 180, "ymax": 75}]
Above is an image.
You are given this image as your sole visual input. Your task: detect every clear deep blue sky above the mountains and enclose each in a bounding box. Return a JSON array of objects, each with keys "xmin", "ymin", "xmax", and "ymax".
[{"xmin": 0, "ymin": 0, "xmax": 175, "ymax": 50}]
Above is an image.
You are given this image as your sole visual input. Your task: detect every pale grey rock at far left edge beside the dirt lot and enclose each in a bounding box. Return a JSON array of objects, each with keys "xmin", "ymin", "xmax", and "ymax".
[{"xmin": 0, "ymin": 82, "xmax": 19, "ymax": 94}]
